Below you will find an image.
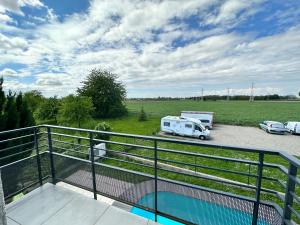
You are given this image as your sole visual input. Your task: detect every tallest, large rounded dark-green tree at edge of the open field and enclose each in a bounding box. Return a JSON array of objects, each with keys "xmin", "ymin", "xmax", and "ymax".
[{"xmin": 77, "ymin": 69, "xmax": 127, "ymax": 118}]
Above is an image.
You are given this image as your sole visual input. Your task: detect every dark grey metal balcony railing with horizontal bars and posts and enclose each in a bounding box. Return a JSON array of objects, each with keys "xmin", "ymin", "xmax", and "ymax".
[{"xmin": 0, "ymin": 124, "xmax": 300, "ymax": 224}]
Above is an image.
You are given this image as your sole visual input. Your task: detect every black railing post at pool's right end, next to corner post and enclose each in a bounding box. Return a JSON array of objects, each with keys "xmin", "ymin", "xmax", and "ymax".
[{"xmin": 252, "ymin": 152, "xmax": 264, "ymax": 225}]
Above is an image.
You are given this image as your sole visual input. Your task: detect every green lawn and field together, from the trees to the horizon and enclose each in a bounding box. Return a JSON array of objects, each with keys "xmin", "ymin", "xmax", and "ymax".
[{"xmin": 76, "ymin": 100, "xmax": 300, "ymax": 135}]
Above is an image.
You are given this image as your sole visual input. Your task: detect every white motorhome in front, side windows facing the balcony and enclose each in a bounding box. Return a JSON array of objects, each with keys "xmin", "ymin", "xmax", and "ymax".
[{"xmin": 161, "ymin": 116, "xmax": 210, "ymax": 140}]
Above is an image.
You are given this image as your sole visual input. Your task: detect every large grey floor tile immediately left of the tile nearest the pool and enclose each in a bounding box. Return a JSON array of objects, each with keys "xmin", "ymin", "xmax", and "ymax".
[{"xmin": 43, "ymin": 196, "xmax": 109, "ymax": 225}]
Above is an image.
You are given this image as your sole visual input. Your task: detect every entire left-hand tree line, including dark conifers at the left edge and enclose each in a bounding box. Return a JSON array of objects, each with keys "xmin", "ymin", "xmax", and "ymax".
[{"xmin": 0, "ymin": 69, "xmax": 127, "ymax": 165}]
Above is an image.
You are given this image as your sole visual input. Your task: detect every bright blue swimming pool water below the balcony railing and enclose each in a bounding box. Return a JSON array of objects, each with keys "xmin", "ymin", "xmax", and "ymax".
[{"xmin": 131, "ymin": 192, "xmax": 270, "ymax": 225}]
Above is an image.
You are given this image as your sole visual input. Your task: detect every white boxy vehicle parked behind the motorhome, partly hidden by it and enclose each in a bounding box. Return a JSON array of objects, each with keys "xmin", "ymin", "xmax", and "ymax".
[{"xmin": 180, "ymin": 111, "xmax": 214, "ymax": 129}]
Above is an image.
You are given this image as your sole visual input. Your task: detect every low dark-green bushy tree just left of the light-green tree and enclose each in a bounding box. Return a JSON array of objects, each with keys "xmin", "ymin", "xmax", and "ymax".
[{"xmin": 36, "ymin": 96, "xmax": 59, "ymax": 123}]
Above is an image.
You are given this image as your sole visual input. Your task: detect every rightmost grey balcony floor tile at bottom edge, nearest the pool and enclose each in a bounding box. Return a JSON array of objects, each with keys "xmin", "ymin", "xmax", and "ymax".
[{"xmin": 95, "ymin": 206, "xmax": 148, "ymax": 225}]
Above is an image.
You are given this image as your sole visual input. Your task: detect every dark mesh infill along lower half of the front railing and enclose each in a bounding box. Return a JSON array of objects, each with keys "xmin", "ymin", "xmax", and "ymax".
[{"xmin": 54, "ymin": 155, "xmax": 281, "ymax": 225}]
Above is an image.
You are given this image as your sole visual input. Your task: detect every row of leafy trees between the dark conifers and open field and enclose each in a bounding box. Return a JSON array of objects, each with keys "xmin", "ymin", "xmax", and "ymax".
[{"xmin": 24, "ymin": 69, "xmax": 127, "ymax": 127}]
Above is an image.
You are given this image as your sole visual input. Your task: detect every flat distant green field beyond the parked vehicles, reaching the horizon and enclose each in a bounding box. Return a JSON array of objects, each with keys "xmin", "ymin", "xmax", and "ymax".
[{"xmin": 127, "ymin": 100, "xmax": 300, "ymax": 126}]
